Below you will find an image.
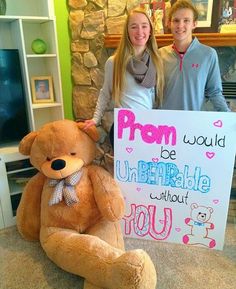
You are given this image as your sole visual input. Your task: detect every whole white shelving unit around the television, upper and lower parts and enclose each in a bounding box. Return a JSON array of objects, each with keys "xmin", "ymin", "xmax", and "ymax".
[{"xmin": 0, "ymin": 0, "xmax": 64, "ymax": 229}]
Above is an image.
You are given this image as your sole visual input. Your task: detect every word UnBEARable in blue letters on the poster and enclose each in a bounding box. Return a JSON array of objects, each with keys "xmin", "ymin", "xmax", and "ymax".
[{"xmin": 115, "ymin": 160, "xmax": 211, "ymax": 193}]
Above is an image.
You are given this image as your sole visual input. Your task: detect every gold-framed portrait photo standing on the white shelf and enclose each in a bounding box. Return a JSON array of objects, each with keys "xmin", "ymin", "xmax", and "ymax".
[{"xmin": 31, "ymin": 76, "xmax": 54, "ymax": 103}]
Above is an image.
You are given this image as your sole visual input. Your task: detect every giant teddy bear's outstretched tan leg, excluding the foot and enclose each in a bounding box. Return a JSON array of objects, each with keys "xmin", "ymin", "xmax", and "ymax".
[{"xmin": 40, "ymin": 226, "xmax": 124, "ymax": 289}]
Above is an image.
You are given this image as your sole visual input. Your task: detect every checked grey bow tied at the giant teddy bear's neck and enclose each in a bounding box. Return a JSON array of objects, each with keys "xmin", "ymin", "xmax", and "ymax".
[{"xmin": 48, "ymin": 171, "xmax": 82, "ymax": 206}]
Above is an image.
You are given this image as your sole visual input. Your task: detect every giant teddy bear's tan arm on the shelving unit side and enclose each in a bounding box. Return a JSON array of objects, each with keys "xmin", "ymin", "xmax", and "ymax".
[{"xmin": 16, "ymin": 173, "xmax": 45, "ymax": 241}]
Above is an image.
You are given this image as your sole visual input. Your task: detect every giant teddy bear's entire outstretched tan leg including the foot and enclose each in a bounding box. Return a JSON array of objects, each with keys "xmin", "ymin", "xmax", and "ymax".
[{"xmin": 40, "ymin": 226, "xmax": 156, "ymax": 289}]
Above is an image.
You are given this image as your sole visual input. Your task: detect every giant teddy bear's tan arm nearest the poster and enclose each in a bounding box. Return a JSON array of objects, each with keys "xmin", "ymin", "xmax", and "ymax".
[{"xmin": 89, "ymin": 166, "xmax": 125, "ymax": 222}]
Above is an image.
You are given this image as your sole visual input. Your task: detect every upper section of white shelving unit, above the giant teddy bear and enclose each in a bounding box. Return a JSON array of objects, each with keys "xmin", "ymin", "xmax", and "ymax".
[{"xmin": 0, "ymin": 0, "xmax": 64, "ymax": 130}]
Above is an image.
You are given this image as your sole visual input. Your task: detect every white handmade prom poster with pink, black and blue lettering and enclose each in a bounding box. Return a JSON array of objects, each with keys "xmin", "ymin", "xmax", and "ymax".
[{"xmin": 114, "ymin": 109, "xmax": 236, "ymax": 250}]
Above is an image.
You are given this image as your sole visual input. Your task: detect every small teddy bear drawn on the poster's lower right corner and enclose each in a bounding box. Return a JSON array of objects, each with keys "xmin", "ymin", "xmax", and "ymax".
[{"xmin": 183, "ymin": 203, "xmax": 216, "ymax": 248}]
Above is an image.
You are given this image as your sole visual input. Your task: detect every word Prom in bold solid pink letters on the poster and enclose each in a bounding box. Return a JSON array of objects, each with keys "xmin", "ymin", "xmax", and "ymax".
[{"xmin": 118, "ymin": 109, "xmax": 177, "ymax": 146}]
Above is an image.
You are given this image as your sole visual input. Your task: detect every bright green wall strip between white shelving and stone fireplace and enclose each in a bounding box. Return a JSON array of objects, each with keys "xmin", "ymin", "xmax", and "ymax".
[{"xmin": 54, "ymin": 0, "xmax": 74, "ymax": 119}]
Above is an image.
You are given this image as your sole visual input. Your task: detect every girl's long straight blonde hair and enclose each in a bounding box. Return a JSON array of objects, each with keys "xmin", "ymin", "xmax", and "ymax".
[{"xmin": 112, "ymin": 8, "xmax": 164, "ymax": 106}]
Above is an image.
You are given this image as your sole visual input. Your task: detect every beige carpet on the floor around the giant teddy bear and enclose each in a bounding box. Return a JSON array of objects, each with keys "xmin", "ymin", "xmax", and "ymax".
[{"xmin": 0, "ymin": 224, "xmax": 236, "ymax": 289}]
